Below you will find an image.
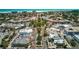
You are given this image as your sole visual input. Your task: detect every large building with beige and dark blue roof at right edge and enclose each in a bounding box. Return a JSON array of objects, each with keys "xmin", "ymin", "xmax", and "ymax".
[{"xmin": 64, "ymin": 27, "xmax": 79, "ymax": 42}]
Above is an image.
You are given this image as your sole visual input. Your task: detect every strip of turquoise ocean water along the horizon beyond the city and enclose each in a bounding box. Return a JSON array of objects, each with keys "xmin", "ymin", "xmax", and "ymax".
[{"xmin": 0, "ymin": 9, "xmax": 76, "ymax": 13}]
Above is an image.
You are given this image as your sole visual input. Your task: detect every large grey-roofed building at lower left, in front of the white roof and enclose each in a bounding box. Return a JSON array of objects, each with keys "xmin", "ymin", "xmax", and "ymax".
[{"xmin": 12, "ymin": 35, "xmax": 29, "ymax": 47}]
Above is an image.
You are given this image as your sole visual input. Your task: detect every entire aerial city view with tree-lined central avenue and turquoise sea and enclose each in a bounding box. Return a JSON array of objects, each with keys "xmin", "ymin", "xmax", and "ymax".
[{"xmin": 0, "ymin": 9, "xmax": 79, "ymax": 49}]
